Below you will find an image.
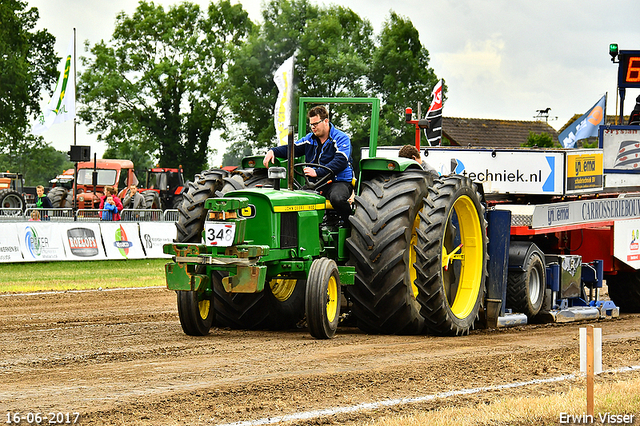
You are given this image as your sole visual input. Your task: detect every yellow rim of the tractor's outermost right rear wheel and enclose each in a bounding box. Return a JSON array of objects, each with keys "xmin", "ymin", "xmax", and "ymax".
[{"xmin": 441, "ymin": 195, "xmax": 484, "ymax": 318}]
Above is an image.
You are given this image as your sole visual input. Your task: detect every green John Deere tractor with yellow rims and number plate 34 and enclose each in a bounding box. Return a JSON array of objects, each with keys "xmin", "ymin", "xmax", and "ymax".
[{"xmin": 164, "ymin": 98, "xmax": 487, "ymax": 338}]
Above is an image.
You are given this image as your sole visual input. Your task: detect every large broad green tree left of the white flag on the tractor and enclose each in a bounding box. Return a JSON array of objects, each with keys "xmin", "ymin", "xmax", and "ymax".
[{"xmin": 79, "ymin": 0, "xmax": 253, "ymax": 176}]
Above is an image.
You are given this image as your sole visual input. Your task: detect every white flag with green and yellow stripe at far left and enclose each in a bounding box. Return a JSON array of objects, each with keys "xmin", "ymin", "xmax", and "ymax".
[{"xmin": 31, "ymin": 37, "xmax": 76, "ymax": 135}]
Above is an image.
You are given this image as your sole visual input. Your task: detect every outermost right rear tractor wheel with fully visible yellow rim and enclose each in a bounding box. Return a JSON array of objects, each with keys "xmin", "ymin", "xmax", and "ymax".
[{"xmin": 415, "ymin": 175, "xmax": 488, "ymax": 335}]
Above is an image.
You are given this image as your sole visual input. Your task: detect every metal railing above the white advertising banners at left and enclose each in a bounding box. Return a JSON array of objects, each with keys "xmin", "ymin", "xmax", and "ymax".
[{"xmin": 0, "ymin": 207, "xmax": 178, "ymax": 222}]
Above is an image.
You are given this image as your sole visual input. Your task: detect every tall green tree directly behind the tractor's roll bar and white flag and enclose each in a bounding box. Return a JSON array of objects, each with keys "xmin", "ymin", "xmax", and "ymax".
[{"xmin": 227, "ymin": 0, "xmax": 373, "ymax": 150}]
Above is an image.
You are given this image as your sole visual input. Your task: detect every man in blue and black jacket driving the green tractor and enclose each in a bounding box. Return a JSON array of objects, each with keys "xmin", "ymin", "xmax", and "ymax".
[{"xmin": 262, "ymin": 106, "xmax": 353, "ymax": 223}]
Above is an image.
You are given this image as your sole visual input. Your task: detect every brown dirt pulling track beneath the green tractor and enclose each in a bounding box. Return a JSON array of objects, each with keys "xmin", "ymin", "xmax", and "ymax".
[{"xmin": 0, "ymin": 288, "xmax": 640, "ymax": 425}]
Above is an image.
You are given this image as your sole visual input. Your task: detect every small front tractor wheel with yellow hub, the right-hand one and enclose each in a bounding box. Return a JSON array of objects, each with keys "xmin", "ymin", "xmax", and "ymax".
[{"xmin": 305, "ymin": 257, "xmax": 340, "ymax": 339}]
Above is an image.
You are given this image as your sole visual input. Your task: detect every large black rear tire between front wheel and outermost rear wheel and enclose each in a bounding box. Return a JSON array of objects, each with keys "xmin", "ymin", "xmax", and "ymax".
[{"xmin": 346, "ymin": 170, "xmax": 430, "ymax": 334}]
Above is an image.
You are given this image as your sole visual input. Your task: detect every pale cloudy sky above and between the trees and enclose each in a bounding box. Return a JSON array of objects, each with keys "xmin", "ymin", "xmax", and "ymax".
[{"xmin": 28, "ymin": 0, "xmax": 640, "ymax": 165}]
